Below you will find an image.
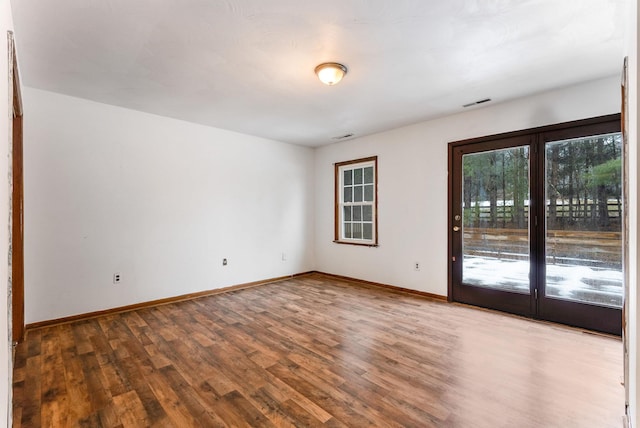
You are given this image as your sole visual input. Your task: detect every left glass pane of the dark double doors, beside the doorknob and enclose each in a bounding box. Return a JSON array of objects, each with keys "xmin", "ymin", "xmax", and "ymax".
[{"xmin": 462, "ymin": 146, "xmax": 530, "ymax": 294}]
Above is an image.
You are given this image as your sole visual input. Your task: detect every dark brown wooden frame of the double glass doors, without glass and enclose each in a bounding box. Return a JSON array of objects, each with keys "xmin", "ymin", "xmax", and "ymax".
[{"xmin": 447, "ymin": 114, "xmax": 622, "ymax": 335}]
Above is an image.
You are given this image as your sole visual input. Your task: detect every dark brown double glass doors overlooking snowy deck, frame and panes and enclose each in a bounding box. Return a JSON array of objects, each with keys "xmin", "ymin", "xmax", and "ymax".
[{"xmin": 449, "ymin": 116, "xmax": 623, "ymax": 334}]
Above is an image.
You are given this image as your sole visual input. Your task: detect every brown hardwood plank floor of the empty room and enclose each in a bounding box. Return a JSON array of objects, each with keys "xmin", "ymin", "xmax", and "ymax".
[{"xmin": 13, "ymin": 274, "xmax": 624, "ymax": 428}]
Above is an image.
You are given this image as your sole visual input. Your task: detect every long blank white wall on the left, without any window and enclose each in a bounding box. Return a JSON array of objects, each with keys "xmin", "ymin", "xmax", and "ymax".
[{"xmin": 24, "ymin": 87, "xmax": 314, "ymax": 323}]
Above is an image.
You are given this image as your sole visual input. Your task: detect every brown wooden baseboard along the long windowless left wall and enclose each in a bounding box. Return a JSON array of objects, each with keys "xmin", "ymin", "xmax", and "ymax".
[{"xmin": 26, "ymin": 271, "xmax": 316, "ymax": 330}]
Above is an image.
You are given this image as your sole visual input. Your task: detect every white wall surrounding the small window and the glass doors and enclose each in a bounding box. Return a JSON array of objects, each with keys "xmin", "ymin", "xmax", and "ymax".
[{"xmin": 315, "ymin": 76, "xmax": 622, "ymax": 295}]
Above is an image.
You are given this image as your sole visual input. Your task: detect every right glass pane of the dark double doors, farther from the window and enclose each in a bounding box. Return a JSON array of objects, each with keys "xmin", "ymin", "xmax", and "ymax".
[{"xmin": 545, "ymin": 133, "xmax": 623, "ymax": 308}]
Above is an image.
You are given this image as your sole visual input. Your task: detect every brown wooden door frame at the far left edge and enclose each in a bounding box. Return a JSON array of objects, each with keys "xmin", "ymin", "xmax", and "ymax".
[{"xmin": 8, "ymin": 32, "xmax": 24, "ymax": 342}]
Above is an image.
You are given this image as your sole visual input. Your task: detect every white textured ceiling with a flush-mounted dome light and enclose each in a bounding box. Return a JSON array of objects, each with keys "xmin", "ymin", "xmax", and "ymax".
[{"xmin": 12, "ymin": 0, "xmax": 633, "ymax": 146}]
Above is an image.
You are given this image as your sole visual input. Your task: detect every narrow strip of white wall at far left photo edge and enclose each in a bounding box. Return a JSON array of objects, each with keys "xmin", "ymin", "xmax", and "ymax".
[{"xmin": 0, "ymin": 1, "xmax": 13, "ymax": 425}]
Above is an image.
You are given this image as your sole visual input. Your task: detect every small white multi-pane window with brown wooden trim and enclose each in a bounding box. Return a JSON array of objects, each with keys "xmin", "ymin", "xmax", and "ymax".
[{"xmin": 335, "ymin": 156, "xmax": 378, "ymax": 246}]
